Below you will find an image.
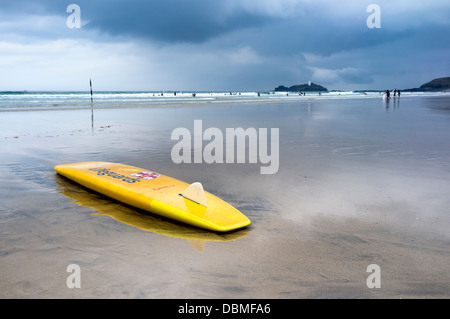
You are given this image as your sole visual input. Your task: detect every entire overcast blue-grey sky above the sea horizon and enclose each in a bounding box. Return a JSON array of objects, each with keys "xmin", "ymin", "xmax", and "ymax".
[{"xmin": 0, "ymin": 0, "xmax": 450, "ymax": 91}]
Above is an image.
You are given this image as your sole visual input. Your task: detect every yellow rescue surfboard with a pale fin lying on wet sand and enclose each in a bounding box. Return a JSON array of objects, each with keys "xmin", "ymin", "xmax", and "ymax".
[{"xmin": 55, "ymin": 162, "xmax": 250, "ymax": 232}]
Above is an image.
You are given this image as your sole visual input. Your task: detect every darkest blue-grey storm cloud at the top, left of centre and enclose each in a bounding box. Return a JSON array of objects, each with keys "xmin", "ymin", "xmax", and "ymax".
[{"xmin": 84, "ymin": 0, "xmax": 276, "ymax": 43}]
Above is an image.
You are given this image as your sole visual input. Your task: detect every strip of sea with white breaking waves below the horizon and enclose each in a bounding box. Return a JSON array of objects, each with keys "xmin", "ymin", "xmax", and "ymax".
[{"xmin": 0, "ymin": 91, "xmax": 436, "ymax": 111}]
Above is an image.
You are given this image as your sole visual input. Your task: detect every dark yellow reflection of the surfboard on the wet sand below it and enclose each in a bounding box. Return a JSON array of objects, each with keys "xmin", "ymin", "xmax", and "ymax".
[{"xmin": 55, "ymin": 175, "xmax": 250, "ymax": 251}]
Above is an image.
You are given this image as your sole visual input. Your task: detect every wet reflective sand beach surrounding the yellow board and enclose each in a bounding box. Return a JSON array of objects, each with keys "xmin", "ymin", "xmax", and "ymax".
[{"xmin": 0, "ymin": 96, "xmax": 450, "ymax": 299}]
